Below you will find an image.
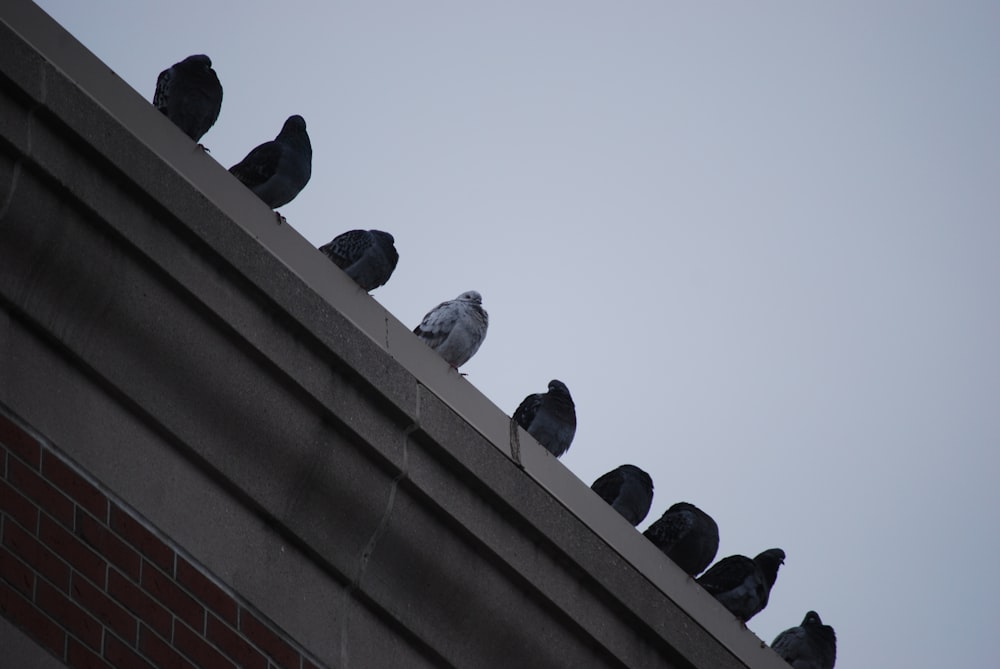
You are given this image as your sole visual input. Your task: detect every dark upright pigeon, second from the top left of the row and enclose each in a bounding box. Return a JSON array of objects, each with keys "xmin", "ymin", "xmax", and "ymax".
[{"xmin": 229, "ymin": 116, "xmax": 312, "ymax": 214}]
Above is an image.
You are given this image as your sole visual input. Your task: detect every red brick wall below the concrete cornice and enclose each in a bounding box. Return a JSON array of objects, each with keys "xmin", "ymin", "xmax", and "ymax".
[{"xmin": 0, "ymin": 415, "xmax": 319, "ymax": 669}]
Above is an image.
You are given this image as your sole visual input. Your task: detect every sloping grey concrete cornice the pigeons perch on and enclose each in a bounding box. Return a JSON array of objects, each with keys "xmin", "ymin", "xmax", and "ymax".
[{"xmin": 0, "ymin": 0, "xmax": 785, "ymax": 669}]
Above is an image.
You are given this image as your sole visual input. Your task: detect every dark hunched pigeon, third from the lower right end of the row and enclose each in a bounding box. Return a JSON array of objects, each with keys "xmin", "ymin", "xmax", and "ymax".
[{"xmin": 642, "ymin": 502, "xmax": 719, "ymax": 576}]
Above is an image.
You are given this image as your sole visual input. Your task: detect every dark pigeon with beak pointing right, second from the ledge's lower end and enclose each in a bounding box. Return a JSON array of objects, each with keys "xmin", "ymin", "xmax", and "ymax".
[{"xmin": 698, "ymin": 548, "xmax": 785, "ymax": 623}]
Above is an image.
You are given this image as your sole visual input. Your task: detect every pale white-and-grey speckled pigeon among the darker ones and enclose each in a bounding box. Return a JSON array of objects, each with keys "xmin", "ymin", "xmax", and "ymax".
[{"xmin": 413, "ymin": 290, "xmax": 490, "ymax": 370}]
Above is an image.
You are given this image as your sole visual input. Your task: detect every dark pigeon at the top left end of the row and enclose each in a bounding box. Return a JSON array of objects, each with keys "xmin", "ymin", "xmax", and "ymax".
[{"xmin": 153, "ymin": 55, "xmax": 222, "ymax": 142}]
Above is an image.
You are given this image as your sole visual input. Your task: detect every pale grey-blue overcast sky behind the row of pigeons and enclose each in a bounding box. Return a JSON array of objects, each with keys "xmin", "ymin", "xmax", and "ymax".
[{"xmin": 40, "ymin": 0, "xmax": 1000, "ymax": 669}]
